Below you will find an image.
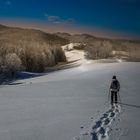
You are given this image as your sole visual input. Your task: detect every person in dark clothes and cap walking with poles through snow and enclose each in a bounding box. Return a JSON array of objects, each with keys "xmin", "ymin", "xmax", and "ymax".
[{"xmin": 110, "ymin": 75, "xmax": 120, "ymax": 105}]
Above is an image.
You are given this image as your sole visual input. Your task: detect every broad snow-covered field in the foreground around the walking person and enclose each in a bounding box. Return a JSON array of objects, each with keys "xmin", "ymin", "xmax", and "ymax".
[{"xmin": 0, "ymin": 62, "xmax": 140, "ymax": 140}]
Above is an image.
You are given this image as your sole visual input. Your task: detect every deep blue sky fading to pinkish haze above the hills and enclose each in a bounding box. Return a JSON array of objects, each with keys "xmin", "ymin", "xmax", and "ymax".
[{"xmin": 0, "ymin": 0, "xmax": 140, "ymax": 38}]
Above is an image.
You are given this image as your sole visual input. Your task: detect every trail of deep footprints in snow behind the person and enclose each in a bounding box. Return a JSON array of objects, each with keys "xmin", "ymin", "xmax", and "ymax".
[{"xmin": 74, "ymin": 105, "xmax": 121, "ymax": 140}]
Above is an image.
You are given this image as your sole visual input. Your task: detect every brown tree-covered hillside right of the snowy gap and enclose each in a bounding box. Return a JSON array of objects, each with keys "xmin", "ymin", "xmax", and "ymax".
[{"xmin": 55, "ymin": 33, "xmax": 140, "ymax": 61}]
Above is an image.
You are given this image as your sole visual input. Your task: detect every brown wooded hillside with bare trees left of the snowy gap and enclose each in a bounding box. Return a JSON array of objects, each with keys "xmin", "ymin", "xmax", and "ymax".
[{"xmin": 0, "ymin": 25, "xmax": 68, "ymax": 72}]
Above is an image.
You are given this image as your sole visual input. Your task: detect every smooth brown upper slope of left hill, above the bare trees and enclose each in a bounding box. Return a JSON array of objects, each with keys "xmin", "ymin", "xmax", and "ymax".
[{"xmin": 0, "ymin": 25, "xmax": 68, "ymax": 45}]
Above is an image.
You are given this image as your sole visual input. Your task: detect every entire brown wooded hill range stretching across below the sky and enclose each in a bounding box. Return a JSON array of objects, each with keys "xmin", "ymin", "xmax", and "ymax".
[{"xmin": 0, "ymin": 25, "xmax": 140, "ymax": 77}]
